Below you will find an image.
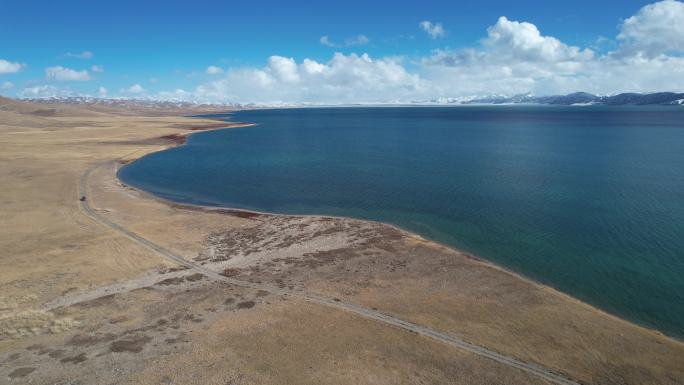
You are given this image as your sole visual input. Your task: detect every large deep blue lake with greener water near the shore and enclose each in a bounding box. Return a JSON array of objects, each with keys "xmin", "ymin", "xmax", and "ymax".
[{"xmin": 119, "ymin": 106, "xmax": 684, "ymax": 338}]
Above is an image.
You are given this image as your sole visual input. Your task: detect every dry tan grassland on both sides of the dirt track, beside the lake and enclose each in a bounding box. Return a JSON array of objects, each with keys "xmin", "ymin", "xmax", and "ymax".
[{"xmin": 0, "ymin": 97, "xmax": 684, "ymax": 384}]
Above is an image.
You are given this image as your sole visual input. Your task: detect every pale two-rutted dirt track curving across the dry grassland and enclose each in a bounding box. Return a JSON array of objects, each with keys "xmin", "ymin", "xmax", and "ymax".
[{"xmin": 79, "ymin": 161, "xmax": 581, "ymax": 385}]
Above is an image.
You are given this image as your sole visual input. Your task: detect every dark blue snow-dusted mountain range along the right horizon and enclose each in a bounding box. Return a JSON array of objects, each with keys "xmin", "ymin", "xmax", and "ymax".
[{"xmin": 420, "ymin": 92, "xmax": 684, "ymax": 106}]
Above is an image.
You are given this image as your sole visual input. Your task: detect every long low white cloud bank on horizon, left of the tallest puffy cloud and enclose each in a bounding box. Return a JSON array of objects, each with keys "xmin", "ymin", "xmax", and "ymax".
[{"xmin": 192, "ymin": 53, "xmax": 422, "ymax": 103}]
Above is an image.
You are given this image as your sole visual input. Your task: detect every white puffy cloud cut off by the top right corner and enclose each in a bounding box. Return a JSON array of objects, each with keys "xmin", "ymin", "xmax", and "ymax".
[{"xmin": 617, "ymin": 0, "xmax": 684, "ymax": 57}]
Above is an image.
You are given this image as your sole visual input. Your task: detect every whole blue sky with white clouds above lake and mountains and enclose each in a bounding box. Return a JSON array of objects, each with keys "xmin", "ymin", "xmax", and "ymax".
[{"xmin": 0, "ymin": 0, "xmax": 684, "ymax": 104}]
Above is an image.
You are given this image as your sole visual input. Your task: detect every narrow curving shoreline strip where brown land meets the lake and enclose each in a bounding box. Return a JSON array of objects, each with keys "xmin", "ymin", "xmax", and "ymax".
[{"xmin": 112, "ymin": 111, "xmax": 684, "ymax": 346}]
